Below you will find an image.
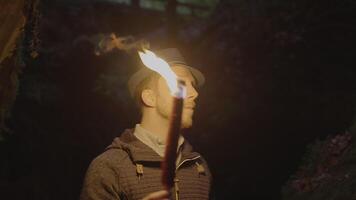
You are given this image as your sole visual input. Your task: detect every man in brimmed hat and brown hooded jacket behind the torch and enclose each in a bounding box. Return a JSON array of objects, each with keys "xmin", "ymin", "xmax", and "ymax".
[{"xmin": 81, "ymin": 49, "xmax": 211, "ymax": 200}]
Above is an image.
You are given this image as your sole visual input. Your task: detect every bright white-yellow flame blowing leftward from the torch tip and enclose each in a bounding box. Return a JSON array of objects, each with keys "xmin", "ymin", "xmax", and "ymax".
[{"xmin": 138, "ymin": 49, "xmax": 186, "ymax": 98}]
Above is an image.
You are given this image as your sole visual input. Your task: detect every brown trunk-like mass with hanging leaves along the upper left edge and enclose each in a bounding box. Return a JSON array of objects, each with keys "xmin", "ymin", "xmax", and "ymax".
[{"xmin": 0, "ymin": 0, "xmax": 39, "ymax": 139}]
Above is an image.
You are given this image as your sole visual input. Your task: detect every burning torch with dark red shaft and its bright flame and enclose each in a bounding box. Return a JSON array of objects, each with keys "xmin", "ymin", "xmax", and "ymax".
[{"xmin": 139, "ymin": 49, "xmax": 186, "ymax": 191}]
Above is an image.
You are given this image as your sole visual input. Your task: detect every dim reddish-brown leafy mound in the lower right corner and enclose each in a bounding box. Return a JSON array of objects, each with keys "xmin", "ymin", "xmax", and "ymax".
[{"xmin": 283, "ymin": 132, "xmax": 356, "ymax": 200}]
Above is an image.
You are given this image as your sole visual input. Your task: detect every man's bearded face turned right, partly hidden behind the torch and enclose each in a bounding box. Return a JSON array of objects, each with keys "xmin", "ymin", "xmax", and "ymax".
[{"xmin": 156, "ymin": 66, "xmax": 198, "ymax": 128}]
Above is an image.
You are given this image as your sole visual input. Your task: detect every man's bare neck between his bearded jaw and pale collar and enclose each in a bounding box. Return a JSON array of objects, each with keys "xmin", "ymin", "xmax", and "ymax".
[{"xmin": 140, "ymin": 109, "xmax": 169, "ymax": 140}]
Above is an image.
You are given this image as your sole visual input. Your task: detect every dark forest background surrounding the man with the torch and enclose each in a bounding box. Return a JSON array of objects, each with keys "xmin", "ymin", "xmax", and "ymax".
[{"xmin": 0, "ymin": 0, "xmax": 356, "ymax": 200}]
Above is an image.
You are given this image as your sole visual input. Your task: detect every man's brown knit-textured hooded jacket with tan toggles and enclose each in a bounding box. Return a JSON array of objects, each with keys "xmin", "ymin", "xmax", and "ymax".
[{"xmin": 80, "ymin": 130, "xmax": 211, "ymax": 200}]
